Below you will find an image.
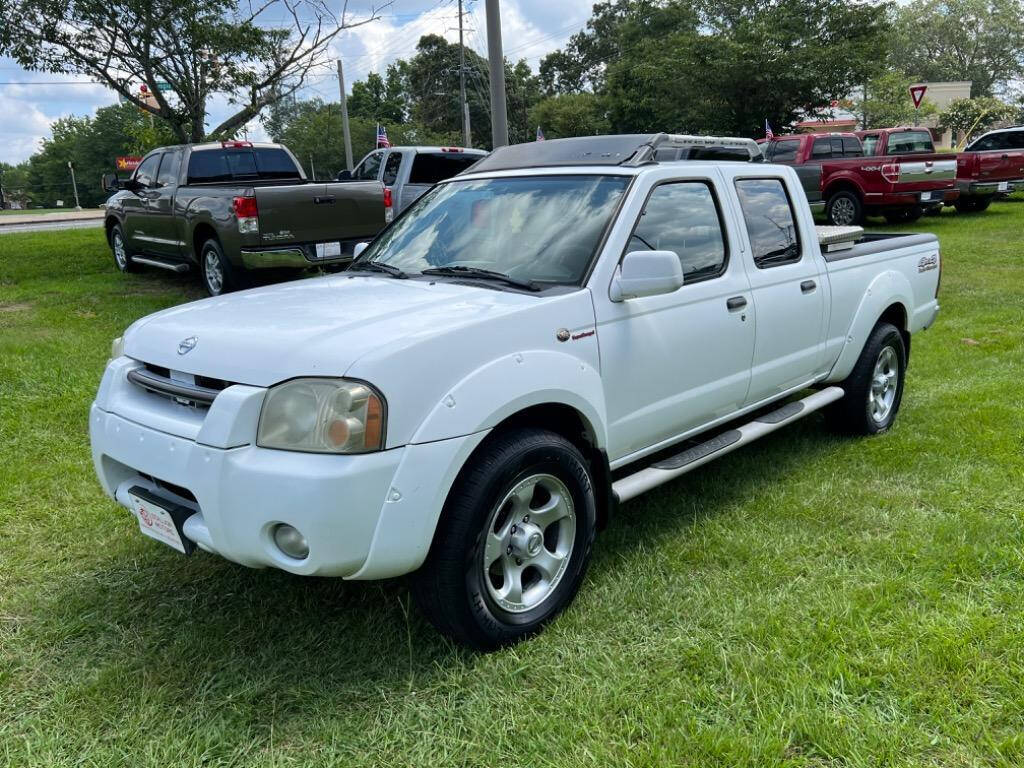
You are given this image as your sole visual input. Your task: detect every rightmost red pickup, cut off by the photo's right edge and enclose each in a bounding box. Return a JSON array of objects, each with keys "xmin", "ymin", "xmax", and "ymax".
[{"xmin": 956, "ymin": 125, "xmax": 1024, "ymax": 212}]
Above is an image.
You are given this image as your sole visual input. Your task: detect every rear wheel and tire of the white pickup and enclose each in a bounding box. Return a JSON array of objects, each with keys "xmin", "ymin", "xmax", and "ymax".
[{"xmin": 827, "ymin": 323, "xmax": 906, "ymax": 435}]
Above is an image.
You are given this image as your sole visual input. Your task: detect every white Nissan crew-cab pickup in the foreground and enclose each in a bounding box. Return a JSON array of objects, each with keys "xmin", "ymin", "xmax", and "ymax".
[{"xmin": 90, "ymin": 134, "xmax": 940, "ymax": 649}]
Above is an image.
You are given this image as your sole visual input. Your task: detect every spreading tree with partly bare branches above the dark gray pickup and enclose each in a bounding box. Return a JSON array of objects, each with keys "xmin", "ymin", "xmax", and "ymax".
[{"xmin": 0, "ymin": 0, "xmax": 376, "ymax": 141}]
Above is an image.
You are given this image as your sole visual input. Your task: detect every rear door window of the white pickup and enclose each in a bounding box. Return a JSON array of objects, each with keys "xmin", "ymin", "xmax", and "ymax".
[{"xmin": 736, "ymin": 178, "xmax": 801, "ymax": 269}]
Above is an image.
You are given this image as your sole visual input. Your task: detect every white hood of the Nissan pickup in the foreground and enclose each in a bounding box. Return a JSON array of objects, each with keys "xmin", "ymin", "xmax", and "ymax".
[{"xmin": 125, "ymin": 274, "xmax": 544, "ymax": 386}]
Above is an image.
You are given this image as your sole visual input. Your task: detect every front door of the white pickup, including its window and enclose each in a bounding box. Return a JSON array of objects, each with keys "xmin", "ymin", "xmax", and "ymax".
[{"xmin": 594, "ymin": 178, "xmax": 754, "ymax": 461}]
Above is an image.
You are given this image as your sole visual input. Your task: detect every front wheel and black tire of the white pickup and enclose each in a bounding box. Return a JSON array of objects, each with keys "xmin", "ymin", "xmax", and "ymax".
[{"xmin": 413, "ymin": 428, "xmax": 597, "ymax": 651}]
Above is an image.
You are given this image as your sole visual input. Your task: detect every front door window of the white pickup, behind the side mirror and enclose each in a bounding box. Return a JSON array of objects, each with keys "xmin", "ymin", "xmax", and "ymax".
[{"xmin": 627, "ymin": 181, "xmax": 726, "ymax": 283}]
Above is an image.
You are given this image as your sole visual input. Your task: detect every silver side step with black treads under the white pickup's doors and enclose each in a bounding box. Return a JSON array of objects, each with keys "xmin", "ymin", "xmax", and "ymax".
[{"xmin": 611, "ymin": 387, "xmax": 845, "ymax": 502}]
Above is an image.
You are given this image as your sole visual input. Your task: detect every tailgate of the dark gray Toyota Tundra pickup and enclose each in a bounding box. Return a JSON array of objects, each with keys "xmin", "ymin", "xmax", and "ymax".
[{"xmin": 256, "ymin": 181, "xmax": 384, "ymax": 245}]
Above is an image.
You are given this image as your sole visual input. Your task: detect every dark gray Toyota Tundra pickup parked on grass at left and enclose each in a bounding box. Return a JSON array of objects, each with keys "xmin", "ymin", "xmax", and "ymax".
[{"xmin": 103, "ymin": 141, "xmax": 385, "ymax": 296}]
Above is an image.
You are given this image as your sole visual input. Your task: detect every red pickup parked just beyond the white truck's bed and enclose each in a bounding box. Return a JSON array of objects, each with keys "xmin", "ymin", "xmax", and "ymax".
[{"xmin": 763, "ymin": 133, "xmax": 956, "ymax": 225}]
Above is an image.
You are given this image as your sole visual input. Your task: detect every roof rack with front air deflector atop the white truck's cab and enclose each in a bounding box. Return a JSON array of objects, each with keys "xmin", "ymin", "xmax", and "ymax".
[{"xmin": 470, "ymin": 133, "xmax": 762, "ymax": 173}]
